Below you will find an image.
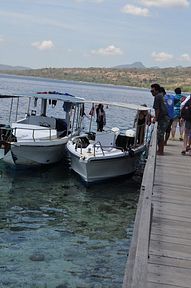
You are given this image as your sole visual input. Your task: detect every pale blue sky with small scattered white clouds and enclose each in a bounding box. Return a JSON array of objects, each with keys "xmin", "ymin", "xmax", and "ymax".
[{"xmin": 0, "ymin": 0, "xmax": 191, "ymax": 68}]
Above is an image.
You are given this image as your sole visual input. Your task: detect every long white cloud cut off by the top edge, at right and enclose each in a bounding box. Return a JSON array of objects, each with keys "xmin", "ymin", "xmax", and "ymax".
[{"xmin": 140, "ymin": 0, "xmax": 190, "ymax": 7}]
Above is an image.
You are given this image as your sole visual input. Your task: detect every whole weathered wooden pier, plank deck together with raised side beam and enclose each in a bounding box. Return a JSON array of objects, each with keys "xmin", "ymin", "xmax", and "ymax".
[{"xmin": 123, "ymin": 129, "xmax": 191, "ymax": 288}]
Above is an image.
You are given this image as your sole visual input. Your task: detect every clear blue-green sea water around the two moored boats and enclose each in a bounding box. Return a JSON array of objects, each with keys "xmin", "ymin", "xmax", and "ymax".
[{"xmin": 0, "ymin": 75, "xmax": 153, "ymax": 288}]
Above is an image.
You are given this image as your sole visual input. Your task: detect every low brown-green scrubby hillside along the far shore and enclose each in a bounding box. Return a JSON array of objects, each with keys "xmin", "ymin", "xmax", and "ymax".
[{"xmin": 1, "ymin": 65, "xmax": 191, "ymax": 93}]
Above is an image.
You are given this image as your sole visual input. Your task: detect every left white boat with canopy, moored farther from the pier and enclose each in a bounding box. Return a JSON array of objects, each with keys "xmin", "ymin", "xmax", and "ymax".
[{"xmin": 0, "ymin": 91, "xmax": 83, "ymax": 166}]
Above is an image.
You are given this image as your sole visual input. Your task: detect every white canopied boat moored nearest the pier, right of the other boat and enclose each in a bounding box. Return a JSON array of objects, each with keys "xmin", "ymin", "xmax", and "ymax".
[{"xmin": 67, "ymin": 102, "xmax": 149, "ymax": 183}]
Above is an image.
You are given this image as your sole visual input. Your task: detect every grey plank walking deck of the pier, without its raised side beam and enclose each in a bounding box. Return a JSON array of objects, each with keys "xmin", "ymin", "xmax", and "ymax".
[{"xmin": 147, "ymin": 141, "xmax": 191, "ymax": 288}]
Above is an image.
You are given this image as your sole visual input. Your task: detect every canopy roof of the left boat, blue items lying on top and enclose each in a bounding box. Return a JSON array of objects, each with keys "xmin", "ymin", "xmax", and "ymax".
[{"xmin": 0, "ymin": 91, "xmax": 84, "ymax": 103}]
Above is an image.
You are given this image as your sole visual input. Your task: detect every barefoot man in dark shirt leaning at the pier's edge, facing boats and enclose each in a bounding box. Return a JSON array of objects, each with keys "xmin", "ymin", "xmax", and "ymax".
[{"xmin": 151, "ymin": 83, "xmax": 170, "ymax": 155}]
